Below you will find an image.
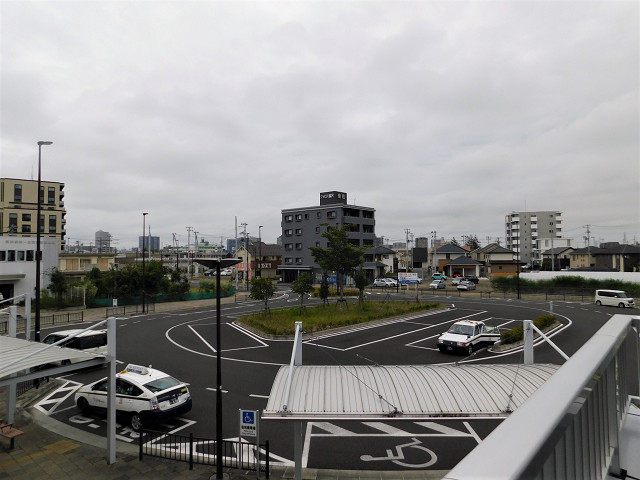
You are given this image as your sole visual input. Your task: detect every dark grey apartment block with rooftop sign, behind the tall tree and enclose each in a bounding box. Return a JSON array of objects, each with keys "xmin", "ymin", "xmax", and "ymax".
[{"xmin": 278, "ymin": 191, "xmax": 376, "ymax": 282}]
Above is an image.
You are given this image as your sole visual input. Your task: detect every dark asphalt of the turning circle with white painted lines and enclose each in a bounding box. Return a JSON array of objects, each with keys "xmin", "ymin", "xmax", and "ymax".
[{"xmin": 33, "ymin": 291, "xmax": 624, "ymax": 470}]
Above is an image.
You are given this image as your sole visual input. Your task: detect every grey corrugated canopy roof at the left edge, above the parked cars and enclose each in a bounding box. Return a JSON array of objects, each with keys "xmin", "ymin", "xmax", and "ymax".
[{"xmin": 0, "ymin": 336, "xmax": 102, "ymax": 379}]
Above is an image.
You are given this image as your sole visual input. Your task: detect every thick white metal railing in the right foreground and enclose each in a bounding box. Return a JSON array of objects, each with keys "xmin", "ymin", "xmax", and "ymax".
[{"xmin": 445, "ymin": 315, "xmax": 640, "ymax": 480}]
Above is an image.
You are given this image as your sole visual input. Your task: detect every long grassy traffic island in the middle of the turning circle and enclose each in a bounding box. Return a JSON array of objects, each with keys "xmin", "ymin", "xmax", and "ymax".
[{"xmin": 240, "ymin": 302, "xmax": 443, "ymax": 335}]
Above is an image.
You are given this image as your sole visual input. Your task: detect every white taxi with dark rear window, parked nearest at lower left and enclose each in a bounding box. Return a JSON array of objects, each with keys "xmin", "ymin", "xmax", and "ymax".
[{"xmin": 74, "ymin": 364, "xmax": 192, "ymax": 431}]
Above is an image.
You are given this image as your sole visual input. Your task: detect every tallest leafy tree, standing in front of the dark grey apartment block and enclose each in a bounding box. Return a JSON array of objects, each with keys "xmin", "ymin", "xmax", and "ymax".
[{"xmin": 309, "ymin": 223, "xmax": 364, "ymax": 302}]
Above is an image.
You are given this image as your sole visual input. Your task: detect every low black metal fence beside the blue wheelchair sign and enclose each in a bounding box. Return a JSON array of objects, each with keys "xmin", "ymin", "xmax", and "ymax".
[{"xmin": 138, "ymin": 430, "xmax": 269, "ymax": 478}]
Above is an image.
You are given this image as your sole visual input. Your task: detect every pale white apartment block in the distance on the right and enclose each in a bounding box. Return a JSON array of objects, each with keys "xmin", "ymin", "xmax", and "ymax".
[{"xmin": 504, "ymin": 211, "xmax": 562, "ymax": 266}]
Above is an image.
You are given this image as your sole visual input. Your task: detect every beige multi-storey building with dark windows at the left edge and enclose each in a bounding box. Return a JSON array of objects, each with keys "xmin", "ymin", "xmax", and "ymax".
[{"xmin": 0, "ymin": 178, "xmax": 67, "ymax": 251}]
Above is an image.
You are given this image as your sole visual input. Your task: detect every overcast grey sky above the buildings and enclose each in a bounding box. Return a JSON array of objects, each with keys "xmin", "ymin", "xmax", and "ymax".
[{"xmin": 0, "ymin": 0, "xmax": 640, "ymax": 249}]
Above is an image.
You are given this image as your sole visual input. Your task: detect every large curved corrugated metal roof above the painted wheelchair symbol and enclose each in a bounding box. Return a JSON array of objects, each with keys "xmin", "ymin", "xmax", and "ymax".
[{"xmin": 263, "ymin": 364, "xmax": 559, "ymax": 420}]
